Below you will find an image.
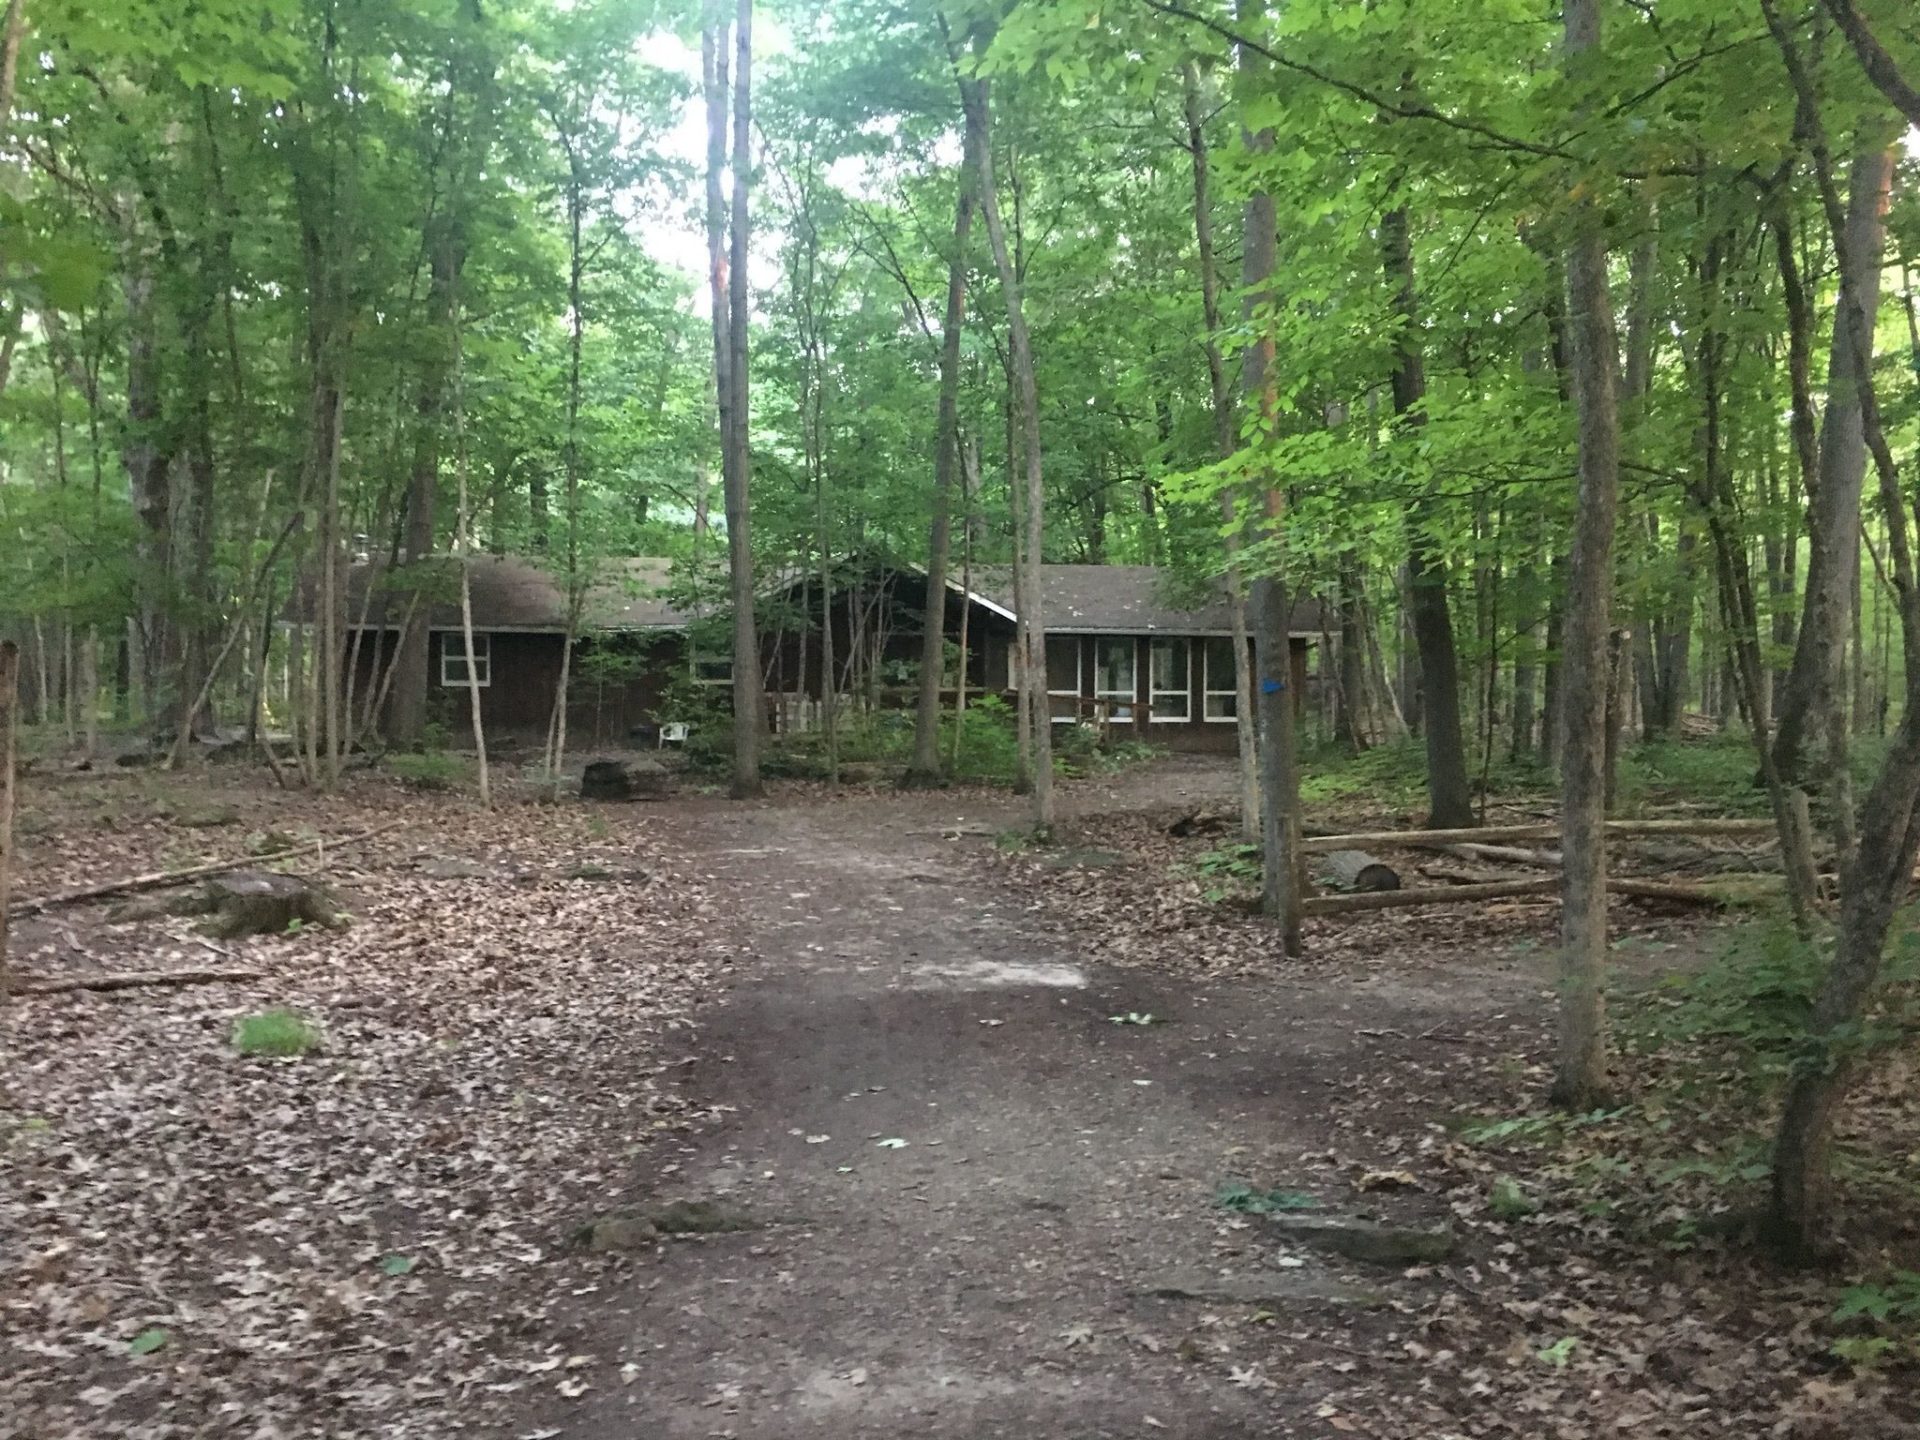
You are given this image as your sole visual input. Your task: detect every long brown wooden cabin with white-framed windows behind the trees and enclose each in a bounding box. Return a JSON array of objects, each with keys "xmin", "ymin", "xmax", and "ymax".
[{"xmin": 314, "ymin": 557, "xmax": 1323, "ymax": 751}]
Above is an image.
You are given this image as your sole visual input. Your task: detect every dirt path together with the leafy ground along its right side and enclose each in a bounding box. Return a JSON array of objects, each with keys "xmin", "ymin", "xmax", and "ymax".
[{"xmin": 506, "ymin": 762, "xmax": 1907, "ymax": 1440}]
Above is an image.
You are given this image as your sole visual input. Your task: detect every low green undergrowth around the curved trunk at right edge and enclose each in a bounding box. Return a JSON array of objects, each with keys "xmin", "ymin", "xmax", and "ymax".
[{"xmin": 1450, "ymin": 925, "xmax": 1920, "ymax": 1367}]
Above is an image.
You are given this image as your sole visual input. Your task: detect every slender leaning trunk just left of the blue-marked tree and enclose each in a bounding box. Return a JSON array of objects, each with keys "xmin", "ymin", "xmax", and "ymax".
[{"xmin": 1181, "ymin": 60, "xmax": 1261, "ymax": 845}]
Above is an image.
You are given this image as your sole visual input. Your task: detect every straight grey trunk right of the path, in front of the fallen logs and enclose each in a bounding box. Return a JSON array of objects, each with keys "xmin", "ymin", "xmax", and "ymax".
[{"xmin": 1553, "ymin": 0, "xmax": 1620, "ymax": 1110}]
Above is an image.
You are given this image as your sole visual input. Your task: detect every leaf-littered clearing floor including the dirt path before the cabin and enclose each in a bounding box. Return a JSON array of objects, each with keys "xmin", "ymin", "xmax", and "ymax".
[{"xmin": 0, "ymin": 762, "xmax": 1912, "ymax": 1440}]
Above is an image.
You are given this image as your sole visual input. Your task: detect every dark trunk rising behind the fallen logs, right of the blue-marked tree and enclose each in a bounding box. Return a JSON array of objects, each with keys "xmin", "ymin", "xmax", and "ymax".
[{"xmin": 1380, "ymin": 205, "xmax": 1473, "ymax": 829}]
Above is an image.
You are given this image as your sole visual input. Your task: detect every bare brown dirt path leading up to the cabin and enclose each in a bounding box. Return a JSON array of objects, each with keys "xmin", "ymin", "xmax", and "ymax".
[{"xmin": 540, "ymin": 772, "xmax": 1532, "ymax": 1440}]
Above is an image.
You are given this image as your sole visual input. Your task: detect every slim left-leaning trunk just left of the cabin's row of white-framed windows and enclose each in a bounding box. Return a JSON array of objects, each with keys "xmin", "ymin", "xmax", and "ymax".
[{"xmin": 960, "ymin": 79, "xmax": 1054, "ymax": 835}]
